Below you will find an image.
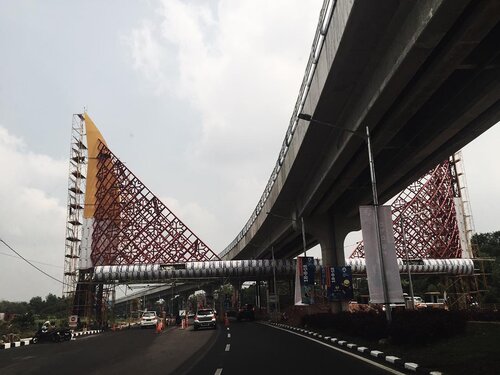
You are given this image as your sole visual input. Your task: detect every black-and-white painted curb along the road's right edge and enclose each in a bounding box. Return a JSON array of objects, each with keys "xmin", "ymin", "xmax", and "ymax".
[{"xmin": 268, "ymin": 322, "xmax": 442, "ymax": 375}]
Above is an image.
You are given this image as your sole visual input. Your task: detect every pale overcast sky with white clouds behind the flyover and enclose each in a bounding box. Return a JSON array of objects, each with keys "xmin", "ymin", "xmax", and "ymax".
[{"xmin": 0, "ymin": 0, "xmax": 500, "ymax": 300}]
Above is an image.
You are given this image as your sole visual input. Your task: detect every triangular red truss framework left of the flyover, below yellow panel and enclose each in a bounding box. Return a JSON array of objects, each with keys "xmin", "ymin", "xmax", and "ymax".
[{"xmin": 91, "ymin": 143, "xmax": 219, "ymax": 266}]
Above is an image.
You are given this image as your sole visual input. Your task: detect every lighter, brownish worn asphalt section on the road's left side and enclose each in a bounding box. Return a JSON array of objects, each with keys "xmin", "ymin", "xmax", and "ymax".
[{"xmin": 0, "ymin": 327, "xmax": 221, "ymax": 375}]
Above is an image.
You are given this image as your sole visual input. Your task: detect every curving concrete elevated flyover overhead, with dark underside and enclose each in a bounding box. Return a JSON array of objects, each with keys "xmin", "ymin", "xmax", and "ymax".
[{"xmin": 220, "ymin": 0, "xmax": 500, "ymax": 265}]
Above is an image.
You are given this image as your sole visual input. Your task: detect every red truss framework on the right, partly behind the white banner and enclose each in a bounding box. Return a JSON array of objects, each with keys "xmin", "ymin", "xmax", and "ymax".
[{"xmin": 350, "ymin": 157, "xmax": 462, "ymax": 259}]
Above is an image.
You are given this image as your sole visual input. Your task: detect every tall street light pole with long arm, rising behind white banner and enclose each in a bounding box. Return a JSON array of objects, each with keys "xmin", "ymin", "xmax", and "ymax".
[{"xmin": 297, "ymin": 113, "xmax": 392, "ymax": 322}]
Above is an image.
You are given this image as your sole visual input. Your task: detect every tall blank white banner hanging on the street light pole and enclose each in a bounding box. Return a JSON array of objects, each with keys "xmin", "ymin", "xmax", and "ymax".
[{"xmin": 359, "ymin": 206, "xmax": 404, "ymax": 303}]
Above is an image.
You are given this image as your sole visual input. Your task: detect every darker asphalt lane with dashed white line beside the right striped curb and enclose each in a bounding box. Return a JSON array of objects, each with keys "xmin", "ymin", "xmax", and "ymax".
[{"xmin": 186, "ymin": 322, "xmax": 401, "ymax": 375}]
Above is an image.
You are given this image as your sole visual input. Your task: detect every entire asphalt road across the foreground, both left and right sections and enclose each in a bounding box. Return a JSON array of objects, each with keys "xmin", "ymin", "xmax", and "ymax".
[{"xmin": 0, "ymin": 322, "xmax": 406, "ymax": 375}]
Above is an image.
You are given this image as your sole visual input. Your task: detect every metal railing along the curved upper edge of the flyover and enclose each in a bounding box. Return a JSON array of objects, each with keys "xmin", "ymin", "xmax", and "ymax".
[{"xmin": 219, "ymin": 0, "xmax": 337, "ymax": 258}]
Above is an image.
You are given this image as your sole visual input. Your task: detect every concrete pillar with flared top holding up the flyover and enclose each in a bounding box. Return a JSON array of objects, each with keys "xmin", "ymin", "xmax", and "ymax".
[{"xmin": 304, "ymin": 213, "xmax": 359, "ymax": 312}]
